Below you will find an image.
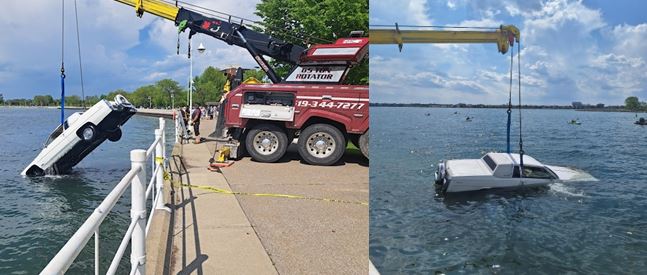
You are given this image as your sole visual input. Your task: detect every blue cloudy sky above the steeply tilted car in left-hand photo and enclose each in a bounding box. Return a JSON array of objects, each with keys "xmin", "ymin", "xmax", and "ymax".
[{"xmin": 0, "ymin": 0, "xmax": 259, "ymax": 99}]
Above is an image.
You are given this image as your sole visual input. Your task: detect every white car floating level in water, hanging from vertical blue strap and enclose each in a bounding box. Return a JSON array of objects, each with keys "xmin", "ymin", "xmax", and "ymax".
[{"xmin": 435, "ymin": 153, "xmax": 584, "ymax": 193}]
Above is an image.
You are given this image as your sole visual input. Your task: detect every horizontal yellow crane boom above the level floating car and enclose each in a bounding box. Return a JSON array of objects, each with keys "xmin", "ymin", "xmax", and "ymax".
[{"xmin": 369, "ymin": 25, "xmax": 520, "ymax": 53}]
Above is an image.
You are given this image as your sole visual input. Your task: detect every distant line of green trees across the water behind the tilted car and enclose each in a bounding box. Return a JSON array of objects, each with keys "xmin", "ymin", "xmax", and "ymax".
[{"xmin": 0, "ymin": 67, "xmax": 265, "ymax": 108}]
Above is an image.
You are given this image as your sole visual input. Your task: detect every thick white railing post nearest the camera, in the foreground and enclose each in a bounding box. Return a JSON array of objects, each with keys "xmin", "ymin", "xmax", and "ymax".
[{"xmin": 130, "ymin": 149, "xmax": 146, "ymax": 274}]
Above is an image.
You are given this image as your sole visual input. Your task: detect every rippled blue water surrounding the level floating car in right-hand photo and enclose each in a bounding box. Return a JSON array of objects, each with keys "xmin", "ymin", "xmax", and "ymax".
[{"xmin": 370, "ymin": 107, "xmax": 647, "ymax": 274}]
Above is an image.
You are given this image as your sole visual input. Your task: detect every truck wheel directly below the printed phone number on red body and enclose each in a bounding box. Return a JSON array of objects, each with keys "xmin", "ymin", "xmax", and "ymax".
[{"xmin": 299, "ymin": 124, "xmax": 346, "ymax": 165}]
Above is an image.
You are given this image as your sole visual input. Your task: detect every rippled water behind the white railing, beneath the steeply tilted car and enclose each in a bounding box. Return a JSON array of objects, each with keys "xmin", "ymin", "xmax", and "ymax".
[{"xmin": 0, "ymin": 108, "xmax": 173, "ymax": 274}]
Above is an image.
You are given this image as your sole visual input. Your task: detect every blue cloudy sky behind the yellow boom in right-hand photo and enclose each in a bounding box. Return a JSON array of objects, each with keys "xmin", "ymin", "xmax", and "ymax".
[{"xmin": 370, "ymin": 0, "xmax": 647, "ymax": 105}]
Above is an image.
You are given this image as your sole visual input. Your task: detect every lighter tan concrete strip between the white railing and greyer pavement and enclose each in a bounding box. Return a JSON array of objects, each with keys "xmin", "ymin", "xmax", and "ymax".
[{"xmin": 170, "ymin": 121, "xmax": 277, "ymax": 275}]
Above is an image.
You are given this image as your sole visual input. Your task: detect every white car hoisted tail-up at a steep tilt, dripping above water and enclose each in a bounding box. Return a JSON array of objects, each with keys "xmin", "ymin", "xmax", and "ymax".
[{"xmin": 21, "ymin": 95, "xmax": 137, "ymax": 176}]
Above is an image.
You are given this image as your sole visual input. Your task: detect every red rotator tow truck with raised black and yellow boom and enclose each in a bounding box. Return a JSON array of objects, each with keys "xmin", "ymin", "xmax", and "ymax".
[{"xmin": 116, "ymin": 0, "xmax": 369, "ymax": 165}]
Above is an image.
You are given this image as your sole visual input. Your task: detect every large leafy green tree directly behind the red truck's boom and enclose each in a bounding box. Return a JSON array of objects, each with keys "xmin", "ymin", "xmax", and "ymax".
[{"xmin": 255, "ymin": 0, "xmax": 368, "ymax": 84}]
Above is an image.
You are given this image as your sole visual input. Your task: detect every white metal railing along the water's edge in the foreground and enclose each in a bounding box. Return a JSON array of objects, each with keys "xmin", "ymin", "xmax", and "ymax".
[{"xmin": 40, "ymin": 118, "xmax": 170, "ymax": 274}]
